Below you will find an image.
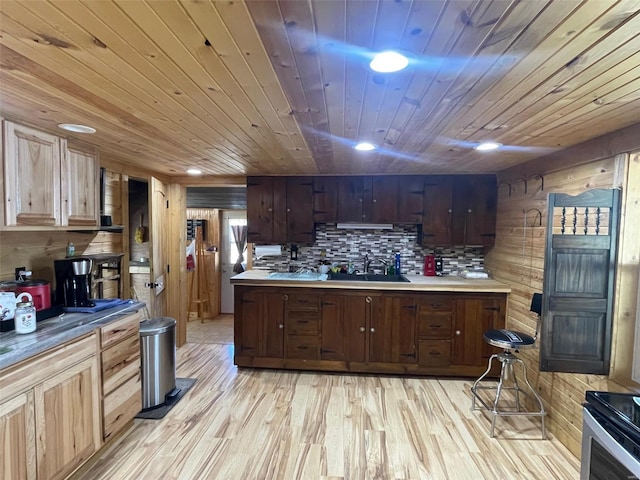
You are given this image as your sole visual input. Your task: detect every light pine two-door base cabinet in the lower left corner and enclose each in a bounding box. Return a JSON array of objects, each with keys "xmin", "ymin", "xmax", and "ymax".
[{"xmin": 0, "ymin": 335, "xmax": 102, "ymax": 480}]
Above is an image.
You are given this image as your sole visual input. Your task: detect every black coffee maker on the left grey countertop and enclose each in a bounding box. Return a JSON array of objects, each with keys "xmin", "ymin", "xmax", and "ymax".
[{"xmin": 53, "ymin": 257, "xmax": 95, "ymax": 307}]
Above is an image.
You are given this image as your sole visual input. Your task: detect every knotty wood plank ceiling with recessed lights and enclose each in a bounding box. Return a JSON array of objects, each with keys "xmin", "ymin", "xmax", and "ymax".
[{"xmin": 0, "ymin": 0, "xmax": 640, "ymax": 176}]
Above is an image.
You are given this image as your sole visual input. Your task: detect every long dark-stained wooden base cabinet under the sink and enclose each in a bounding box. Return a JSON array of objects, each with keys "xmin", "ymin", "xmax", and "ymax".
[{"xmin": 235, "ymin": 285, "xmax": 507, "ymax": 376}]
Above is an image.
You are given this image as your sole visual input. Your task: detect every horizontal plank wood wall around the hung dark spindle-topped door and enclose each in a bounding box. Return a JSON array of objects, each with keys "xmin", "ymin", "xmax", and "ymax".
[{"xmin": 485, "ymin": 150, "xmax": 636, "ymax": 456}]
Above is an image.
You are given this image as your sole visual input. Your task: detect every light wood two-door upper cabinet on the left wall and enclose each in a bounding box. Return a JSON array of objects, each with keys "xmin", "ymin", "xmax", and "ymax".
[{"xmin": 0, "ymin": 121, "xmax": 99, "ymax": 229}]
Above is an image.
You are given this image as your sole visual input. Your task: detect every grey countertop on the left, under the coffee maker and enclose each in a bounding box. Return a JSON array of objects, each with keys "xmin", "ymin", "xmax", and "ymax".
[{"xmin": 0, "ymin": 300, "xmax": 145, "ymax": 369}]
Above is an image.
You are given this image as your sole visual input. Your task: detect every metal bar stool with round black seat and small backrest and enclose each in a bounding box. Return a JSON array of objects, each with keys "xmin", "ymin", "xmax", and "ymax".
[{"xmin": 471, "ymin": 293, "xmax": 547, "ymax": 439}]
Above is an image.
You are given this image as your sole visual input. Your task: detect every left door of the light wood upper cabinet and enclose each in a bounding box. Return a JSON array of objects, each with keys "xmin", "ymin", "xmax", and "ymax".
[{"xmin": 3, "ymin": 121, "xmax": 61, "ymax": 226}]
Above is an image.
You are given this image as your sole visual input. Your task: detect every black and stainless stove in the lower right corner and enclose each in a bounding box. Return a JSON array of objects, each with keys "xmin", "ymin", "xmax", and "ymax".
[{"xmin": 580, "ymin": 391, "xmax": 640, "ymax": 480}]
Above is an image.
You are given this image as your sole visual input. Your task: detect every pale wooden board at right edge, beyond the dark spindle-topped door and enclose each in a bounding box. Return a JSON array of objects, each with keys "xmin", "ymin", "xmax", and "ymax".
[{"xmin": 610, "ymin": 152, "xmax": 640, "ymax": 383}]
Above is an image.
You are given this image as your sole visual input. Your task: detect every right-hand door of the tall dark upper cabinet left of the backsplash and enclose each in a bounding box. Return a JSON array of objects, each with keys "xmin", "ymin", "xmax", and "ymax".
[{"xmin": 286, "ymin": 177, "xmax": 315, "ymax": 243}]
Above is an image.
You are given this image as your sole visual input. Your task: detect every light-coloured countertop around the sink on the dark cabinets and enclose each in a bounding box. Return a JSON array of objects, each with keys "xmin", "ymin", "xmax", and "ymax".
[{"xmin": 231, "ymin": 270, "xmax": 511, "ymax": 293}]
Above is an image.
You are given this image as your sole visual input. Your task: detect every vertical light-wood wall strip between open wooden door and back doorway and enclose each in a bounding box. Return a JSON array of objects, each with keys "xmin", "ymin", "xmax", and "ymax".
[{"xmin": 166, "ymin": 184, "xmax": 188, "ymax": 347}]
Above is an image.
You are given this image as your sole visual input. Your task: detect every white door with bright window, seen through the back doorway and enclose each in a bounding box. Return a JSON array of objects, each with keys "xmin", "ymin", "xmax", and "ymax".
[{"xmin": 220, "ymin": 210, "xmax": 247, "ymax": 313}]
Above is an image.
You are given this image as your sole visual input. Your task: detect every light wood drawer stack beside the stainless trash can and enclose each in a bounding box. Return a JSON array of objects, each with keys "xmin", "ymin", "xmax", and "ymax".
[{"xmin": 100, "ymin": 312, "xmax": 143, "ymax": 440}]
